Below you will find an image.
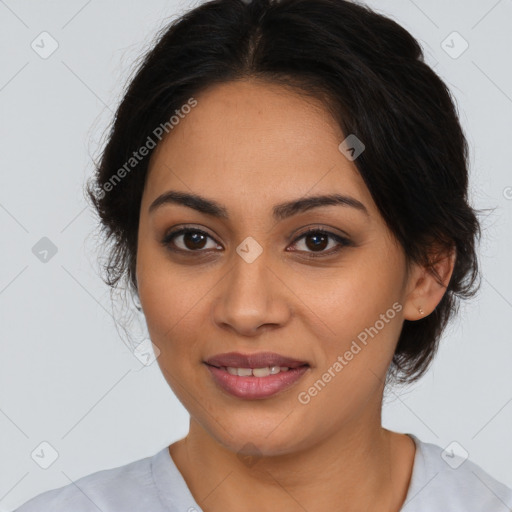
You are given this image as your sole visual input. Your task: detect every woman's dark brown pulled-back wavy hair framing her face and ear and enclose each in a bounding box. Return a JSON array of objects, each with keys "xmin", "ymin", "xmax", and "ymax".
[{"xmin": 87, "ymin": 0, "xmax": 480, "ymax": 383}]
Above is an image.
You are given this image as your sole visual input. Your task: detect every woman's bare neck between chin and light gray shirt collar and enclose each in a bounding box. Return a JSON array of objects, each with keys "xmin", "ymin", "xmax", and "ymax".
[{"xmin": 170, "ymin": 414, "xmax": 414, "ymax": 512}]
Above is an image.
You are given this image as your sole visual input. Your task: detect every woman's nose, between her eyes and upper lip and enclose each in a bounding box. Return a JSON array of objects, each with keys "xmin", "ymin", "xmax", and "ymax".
[{"xmin": 212, "ymin": 247, "xmax": 291, "ymax": 336}]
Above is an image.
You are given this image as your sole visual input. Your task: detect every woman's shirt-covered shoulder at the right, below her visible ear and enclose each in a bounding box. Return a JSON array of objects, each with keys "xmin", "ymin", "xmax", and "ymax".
[{"xmin": 401, "ymin": 434, "xmax": 512, "ymax": 512}]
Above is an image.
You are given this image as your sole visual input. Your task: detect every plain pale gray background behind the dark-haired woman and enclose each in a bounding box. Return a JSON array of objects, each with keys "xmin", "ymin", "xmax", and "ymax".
[{"xmin": 0, "ymin": 0, "xmax": 512, "ymax": 511}]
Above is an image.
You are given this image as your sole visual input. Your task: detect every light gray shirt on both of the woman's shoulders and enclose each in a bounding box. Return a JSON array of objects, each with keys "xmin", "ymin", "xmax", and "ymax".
[{"xmin": 13, "ymin": 434, "xmax": 512, "ymax": 512}]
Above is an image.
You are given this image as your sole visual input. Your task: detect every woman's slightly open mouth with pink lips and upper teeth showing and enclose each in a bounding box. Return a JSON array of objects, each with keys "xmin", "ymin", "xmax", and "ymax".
[{"xmin": 204, "ymin": 352, "xmax": 310, "ymax": 400}]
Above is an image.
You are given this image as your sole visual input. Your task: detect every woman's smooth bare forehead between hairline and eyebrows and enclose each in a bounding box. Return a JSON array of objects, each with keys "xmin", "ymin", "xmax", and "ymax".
[{"xmin": 145, "ymin": 81, "xmax": 373, "ymax": 217}]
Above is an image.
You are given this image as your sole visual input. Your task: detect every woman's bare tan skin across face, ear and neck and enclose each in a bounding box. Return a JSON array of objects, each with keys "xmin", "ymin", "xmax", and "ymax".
[{"xmin": 136, "ymin": 80, "xmax": 454, "ymax": 512}]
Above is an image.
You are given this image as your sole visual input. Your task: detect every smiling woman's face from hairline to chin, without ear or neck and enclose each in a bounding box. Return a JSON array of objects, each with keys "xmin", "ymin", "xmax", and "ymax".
[{"xmin": 137, "ymin": 82, "xmax": 420, "ymax": 454}]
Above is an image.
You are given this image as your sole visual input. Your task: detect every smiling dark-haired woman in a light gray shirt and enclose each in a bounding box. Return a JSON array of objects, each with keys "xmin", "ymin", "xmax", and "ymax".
[{"xmin": 12, "ymin": 0, "xmax": 512, "ymax": 512}]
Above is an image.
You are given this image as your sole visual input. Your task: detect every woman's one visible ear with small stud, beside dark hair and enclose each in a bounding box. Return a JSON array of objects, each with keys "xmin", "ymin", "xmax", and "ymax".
[{"xmin": 404, "ymin": 247, "xmax": 456, "ymax": 320}]
